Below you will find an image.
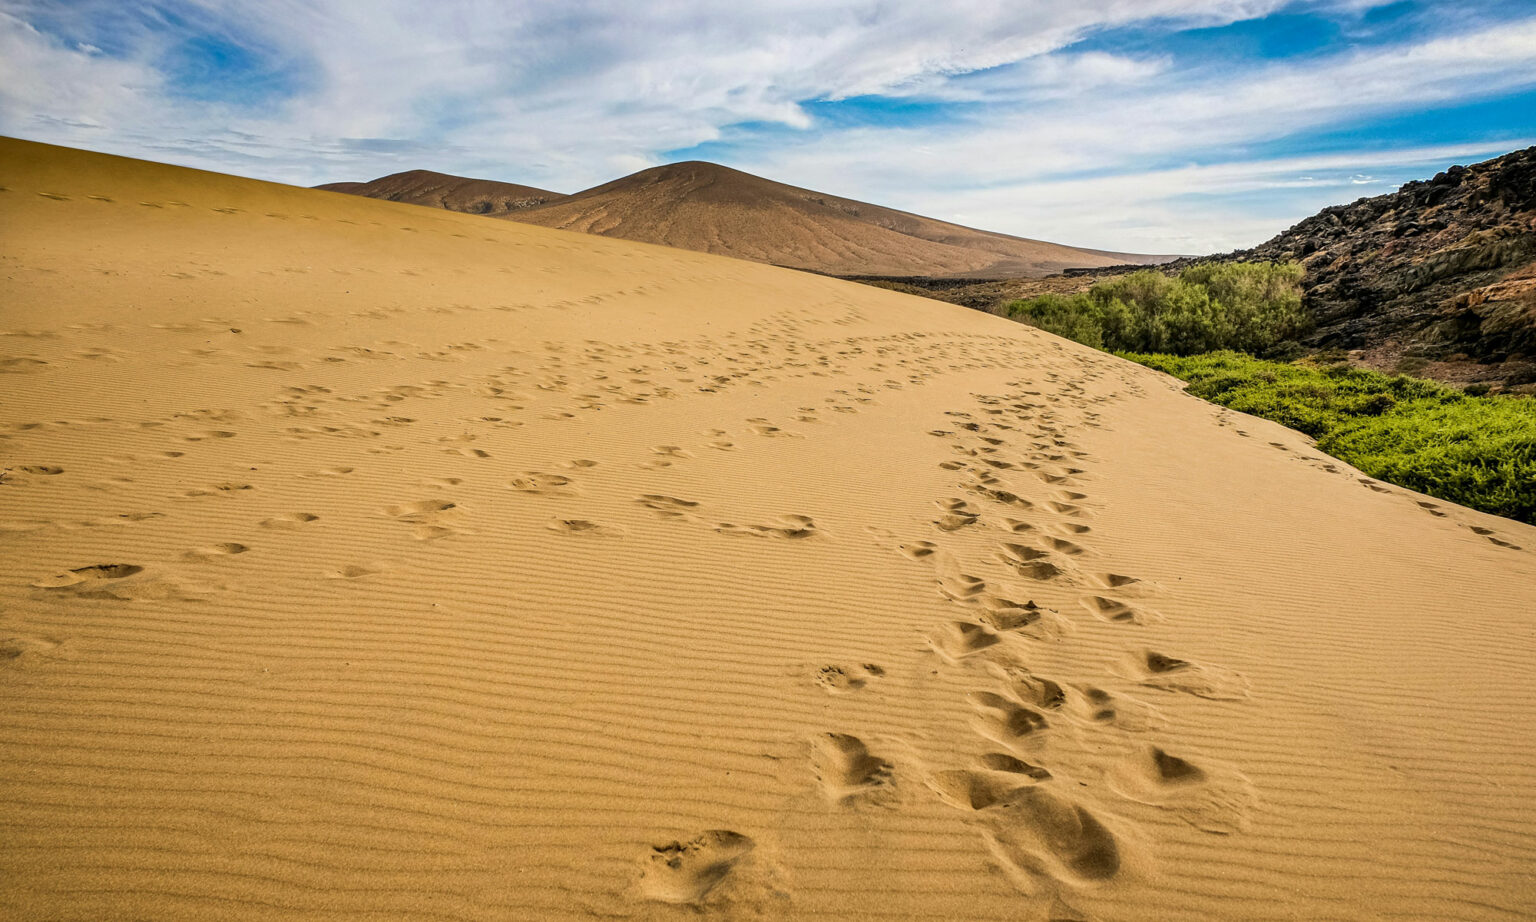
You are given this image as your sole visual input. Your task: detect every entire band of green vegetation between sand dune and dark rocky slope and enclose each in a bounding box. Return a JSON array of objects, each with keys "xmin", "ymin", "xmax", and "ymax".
[{"xmin": 1000, "ymin": 263, "xmax": 1536, "ymax": 524}]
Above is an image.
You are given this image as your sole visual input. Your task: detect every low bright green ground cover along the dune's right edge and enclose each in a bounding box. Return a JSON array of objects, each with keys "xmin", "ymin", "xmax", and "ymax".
[{"xmin": 1124, "ymin": 352, "xmax": 1536, "ymax": 524}]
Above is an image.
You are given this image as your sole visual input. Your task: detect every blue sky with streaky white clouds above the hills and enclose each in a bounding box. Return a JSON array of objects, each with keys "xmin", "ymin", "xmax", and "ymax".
[{"xmin": 0, "ymin": 0, "xmax": 1536, "ymax": 254}]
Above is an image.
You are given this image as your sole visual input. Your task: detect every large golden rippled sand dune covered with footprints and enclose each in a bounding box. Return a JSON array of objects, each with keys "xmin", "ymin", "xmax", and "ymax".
[{"xmin": 9, "ymin": 141, "xmax": 1536, "ymax": 920}]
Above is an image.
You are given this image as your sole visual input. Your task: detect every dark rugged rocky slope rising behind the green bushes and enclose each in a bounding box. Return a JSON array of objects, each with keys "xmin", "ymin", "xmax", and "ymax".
[{"xmin": 1221, "ymin": 148, "xmax": 1536, "ymax": 389}]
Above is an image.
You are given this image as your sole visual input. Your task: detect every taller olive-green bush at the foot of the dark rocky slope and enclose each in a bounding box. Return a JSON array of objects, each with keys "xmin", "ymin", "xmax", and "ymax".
[{"xmin": 1005, "ymin": 263, "xmax": 1307, "ymax": 355}]
